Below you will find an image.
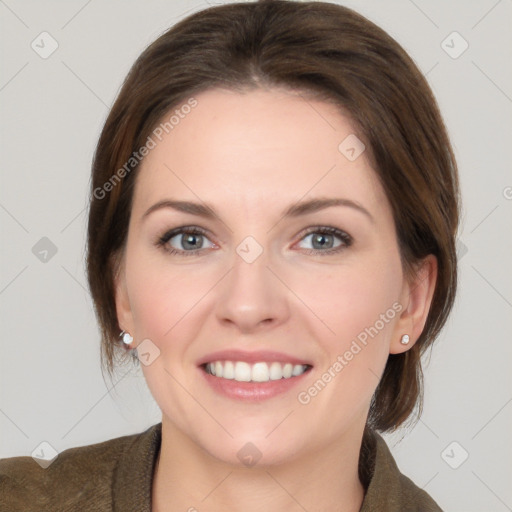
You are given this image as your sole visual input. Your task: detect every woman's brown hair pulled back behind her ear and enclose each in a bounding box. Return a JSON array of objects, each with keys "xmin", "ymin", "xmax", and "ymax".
[{"xmin": 87, "ymin": 0, "xmax": 459, "ymax": 431}]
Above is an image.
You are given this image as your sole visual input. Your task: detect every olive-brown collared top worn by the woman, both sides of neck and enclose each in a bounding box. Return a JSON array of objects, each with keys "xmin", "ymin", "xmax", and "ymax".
[{"xmin": 0, "ymin": 423, "xmax": 442, "ymax": 512}]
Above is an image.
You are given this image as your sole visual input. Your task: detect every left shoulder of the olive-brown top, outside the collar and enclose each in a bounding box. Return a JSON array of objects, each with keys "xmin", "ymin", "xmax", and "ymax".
[{"xmin": 0, "ymin": 428, "xmax": 150, "ymax": 511}]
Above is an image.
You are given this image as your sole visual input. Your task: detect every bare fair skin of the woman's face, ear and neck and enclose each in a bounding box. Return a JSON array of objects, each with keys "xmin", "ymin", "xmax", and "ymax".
[{"xmin": 115, "ymin": 89, "xmax": 437, "ymax": 512}]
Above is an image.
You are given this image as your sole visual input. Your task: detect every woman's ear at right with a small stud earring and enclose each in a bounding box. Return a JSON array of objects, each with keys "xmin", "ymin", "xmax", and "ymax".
[{"xmin": 389, "ymin": 254, "xmax": 437, "ymax": 354}]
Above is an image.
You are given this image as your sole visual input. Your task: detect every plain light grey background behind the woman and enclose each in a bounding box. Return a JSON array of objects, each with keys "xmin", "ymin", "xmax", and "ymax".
[{"xmin": 0, "ymin": 0, "xmax": 512, "ymax": 512}]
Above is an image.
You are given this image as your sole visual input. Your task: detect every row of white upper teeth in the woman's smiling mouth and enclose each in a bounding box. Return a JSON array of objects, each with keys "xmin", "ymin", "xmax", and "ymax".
[{"xmin": 206, "ymin": 361, "xmax": 308, "ymax": 382}]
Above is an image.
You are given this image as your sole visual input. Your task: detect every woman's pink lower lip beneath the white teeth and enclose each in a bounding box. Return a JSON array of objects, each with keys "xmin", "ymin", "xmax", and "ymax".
[{"xmin": 199, "ymin": 367, "xmax": 311, "ymax": 402}]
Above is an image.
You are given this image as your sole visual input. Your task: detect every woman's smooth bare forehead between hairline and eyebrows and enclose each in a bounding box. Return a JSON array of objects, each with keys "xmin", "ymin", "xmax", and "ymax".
[{"xmin": 134, "ymin": 85, "xmax": 385, "ymax": 216}]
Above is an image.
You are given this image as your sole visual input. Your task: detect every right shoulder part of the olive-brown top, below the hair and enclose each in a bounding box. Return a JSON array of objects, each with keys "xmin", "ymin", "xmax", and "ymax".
[{"xmin": 361, "ymin": 433, "xmax": 442, "ymax": 512}]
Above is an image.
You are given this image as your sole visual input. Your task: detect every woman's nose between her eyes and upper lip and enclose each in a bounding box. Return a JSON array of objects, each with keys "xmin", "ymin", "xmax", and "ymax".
[{"xmin": 216, "ymin": 242, "xmax": 290, "ymax": 334}]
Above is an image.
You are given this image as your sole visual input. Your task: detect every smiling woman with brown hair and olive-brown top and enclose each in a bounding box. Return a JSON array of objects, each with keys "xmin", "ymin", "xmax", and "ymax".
[{"xmin": 0, "ymin": 0, "xmax": 459, "ymax": 512}]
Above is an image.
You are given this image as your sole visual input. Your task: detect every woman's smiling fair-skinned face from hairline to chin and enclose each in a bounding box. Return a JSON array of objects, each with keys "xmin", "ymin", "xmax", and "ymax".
[{"xmin": 116, "ymin": 89, "xmax": 428, "ymax": 464}]
